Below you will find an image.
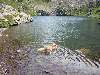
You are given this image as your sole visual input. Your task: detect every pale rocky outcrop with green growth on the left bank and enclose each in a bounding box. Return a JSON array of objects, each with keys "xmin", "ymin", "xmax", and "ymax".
[{"xmin": 0, "ymin": 3, "xmax": 32, "ymax": 28}]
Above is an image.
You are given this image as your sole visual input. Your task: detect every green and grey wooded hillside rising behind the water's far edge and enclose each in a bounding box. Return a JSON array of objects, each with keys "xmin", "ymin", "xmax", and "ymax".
[{"xmin": 0, "ymin": 0, "xmax": 100, "ymax": 18}]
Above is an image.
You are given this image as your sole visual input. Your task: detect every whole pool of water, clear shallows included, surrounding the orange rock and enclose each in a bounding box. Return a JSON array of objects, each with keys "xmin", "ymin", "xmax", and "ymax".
[{"xmin": 0, "ymin": 16, "xmax": 100, "ymax": 75}]
